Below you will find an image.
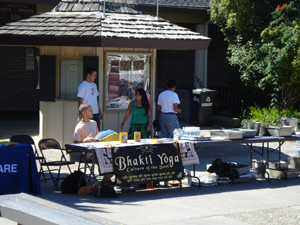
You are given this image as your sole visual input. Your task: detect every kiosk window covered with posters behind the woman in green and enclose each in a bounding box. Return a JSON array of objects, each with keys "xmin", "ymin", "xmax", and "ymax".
[{"xmin": 106, "ymin": 53, "xmax": 151, "ymax": 109}]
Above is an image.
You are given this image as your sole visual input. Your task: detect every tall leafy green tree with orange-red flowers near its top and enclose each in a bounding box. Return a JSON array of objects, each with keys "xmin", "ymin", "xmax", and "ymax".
[{"xmin": 210, "ymin": 0, "xmax": 300, "ymax": 108}]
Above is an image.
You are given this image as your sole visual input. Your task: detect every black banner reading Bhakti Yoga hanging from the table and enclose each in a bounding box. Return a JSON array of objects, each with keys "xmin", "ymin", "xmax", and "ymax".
[{"xmin": 112, "ymin": 143, "xmax": 184, "ymax": 185}]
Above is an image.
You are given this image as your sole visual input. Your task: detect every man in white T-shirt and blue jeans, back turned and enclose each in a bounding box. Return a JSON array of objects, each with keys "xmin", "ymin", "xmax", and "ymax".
[{"xmin": 157, "ymin": 80, "xmax": 181, "ymax": 138}]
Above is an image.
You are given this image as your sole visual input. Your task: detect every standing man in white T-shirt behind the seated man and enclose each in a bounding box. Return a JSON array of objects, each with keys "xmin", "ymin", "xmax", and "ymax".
[{"xmin": 77, "ymin": 67, "xmax": 103, "ymax": 130}]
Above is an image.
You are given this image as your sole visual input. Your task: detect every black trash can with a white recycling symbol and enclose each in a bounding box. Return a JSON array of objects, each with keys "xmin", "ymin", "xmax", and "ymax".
[{"xmin": 190, "ymin": 88, "xmax": 217, "ymax": 126}]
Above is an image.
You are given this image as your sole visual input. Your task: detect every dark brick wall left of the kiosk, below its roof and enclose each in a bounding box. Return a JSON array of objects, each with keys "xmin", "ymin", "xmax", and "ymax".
[{"xmin": 0, "ymin": 47, "xmax": 39, "ymax": 112}]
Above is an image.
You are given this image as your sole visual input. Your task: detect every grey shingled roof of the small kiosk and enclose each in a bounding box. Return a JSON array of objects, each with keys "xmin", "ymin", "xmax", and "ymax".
[{"xmin": 0, "ymin": 0, "xmax": 210, "ymax": 49}]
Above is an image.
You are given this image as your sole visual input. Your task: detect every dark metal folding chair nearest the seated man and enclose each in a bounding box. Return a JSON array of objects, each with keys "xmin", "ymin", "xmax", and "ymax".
[{"xmin": 39, "ymin": 138, "xmax": 75, "ymax": 190}]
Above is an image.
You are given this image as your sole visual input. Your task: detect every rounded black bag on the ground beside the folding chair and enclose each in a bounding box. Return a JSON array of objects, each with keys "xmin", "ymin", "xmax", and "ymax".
[{"xmin": 61, "ymin": 170, "xmax": 86, "ymax": 194}]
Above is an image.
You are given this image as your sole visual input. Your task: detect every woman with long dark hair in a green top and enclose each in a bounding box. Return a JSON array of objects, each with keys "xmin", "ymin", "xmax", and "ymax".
[{"xmin": 121, "ymin": 88, "xmax": 151, "ymax": 139}]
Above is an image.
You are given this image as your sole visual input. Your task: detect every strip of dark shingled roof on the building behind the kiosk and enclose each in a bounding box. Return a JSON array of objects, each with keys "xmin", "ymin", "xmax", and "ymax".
[{"xmin": 135, "ymin": 0, "xmax": 210, "ymax": 9}]
